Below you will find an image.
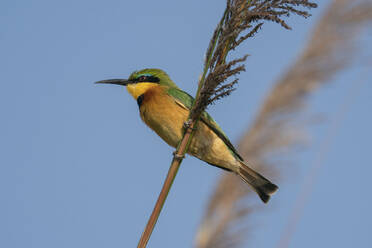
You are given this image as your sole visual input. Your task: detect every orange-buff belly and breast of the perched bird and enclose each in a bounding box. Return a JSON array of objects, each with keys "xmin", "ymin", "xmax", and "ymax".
[{"xmin": 140, "ymin": 96, "xmax": 237, "ymax": 170}]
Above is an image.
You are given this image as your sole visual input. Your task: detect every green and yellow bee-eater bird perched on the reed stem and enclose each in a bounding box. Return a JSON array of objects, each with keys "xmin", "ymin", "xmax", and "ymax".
[{"xmin": 96, "ymin": 68, "xmax": 278, "ymax": 203}]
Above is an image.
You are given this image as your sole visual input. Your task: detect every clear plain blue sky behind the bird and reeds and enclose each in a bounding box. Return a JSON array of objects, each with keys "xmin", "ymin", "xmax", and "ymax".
[{"xmin": 0, "ymin": 0, "xmax": 372, "ymax": 248}]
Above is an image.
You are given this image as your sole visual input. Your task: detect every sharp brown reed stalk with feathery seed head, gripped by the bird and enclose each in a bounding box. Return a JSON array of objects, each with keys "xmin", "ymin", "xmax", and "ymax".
[{"xmin": 137, "ymin": 0, "xmax": 317, "ymax": 248}]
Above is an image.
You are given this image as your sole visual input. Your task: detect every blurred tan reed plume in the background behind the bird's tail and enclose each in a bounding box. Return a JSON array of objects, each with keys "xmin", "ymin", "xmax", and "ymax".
[{"xmin": 195, "ymin": 0, "xmax": 372, "ymax": 248}]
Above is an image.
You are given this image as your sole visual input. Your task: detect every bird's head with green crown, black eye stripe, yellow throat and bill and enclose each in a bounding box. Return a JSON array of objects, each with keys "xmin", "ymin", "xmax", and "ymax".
[{"xmin": 96, "ymin": 69, "xmax": 178, "ymax": 99}]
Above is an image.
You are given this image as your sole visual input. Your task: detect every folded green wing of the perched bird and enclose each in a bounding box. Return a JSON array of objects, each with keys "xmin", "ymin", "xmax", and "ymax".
[{"xmin": 168, "ymin": 88, "xmax": 243, "ymax": 161}]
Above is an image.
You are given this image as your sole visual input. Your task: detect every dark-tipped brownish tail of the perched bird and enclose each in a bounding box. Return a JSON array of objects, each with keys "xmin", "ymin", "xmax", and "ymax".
[{"xmin": 238, "ymin": 161, "xmax": 278, "ymax": 203}]
